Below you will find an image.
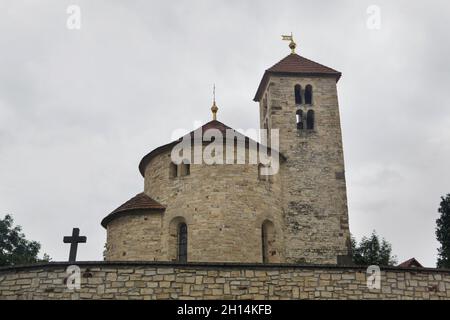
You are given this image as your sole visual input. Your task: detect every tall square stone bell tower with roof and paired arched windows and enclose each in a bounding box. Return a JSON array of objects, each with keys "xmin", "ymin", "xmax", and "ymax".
[{"xmin": 254, "ymin": 35, "xmax": 351, "ymax": 264}]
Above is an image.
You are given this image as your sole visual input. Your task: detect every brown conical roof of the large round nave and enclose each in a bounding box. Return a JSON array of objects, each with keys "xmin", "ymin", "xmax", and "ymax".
[{"xmin": 139, "ymin": 120, "xmax": 286, "ymax": 177}]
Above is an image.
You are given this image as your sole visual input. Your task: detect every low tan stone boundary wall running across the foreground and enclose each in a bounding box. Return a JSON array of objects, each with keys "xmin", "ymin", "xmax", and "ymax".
[{"xmin": 0, "ymin": 262, "xmax": 450, "ymax": 300}]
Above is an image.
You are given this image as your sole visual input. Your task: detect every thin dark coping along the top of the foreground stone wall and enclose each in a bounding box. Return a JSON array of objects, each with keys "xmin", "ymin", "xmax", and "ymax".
[{"xmin": 0, "ymin": 261, "xmax": 450, "ymax": 274}]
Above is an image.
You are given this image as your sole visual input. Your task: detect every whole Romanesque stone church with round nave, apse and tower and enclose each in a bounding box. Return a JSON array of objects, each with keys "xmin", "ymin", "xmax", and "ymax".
[{"xmin": 101, "ymin": 36, "xmax": 351, "ymax": 265}]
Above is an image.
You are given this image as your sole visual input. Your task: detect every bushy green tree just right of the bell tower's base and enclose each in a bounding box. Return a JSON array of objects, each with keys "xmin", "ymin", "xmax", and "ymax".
[{"xmin": 351, "ymin": 230, "xmax": 397, "ymax": 266}]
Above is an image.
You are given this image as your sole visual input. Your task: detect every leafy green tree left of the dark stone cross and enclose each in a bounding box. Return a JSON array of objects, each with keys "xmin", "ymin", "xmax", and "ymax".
[{"xmin": 0, "ymin": 215, "xmax": 50, "ymax": 266}]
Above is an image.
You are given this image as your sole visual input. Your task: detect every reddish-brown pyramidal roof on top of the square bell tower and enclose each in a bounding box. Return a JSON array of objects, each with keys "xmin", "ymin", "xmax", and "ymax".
[{"xmin": 253, "ymin": 53, "xmax": 342, "ymax": 102}]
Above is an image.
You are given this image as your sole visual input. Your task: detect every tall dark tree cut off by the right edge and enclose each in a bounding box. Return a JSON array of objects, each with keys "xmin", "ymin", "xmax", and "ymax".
[{"xmin": 436, "ymin": 194, "xmax": 450, "ymax": 269}]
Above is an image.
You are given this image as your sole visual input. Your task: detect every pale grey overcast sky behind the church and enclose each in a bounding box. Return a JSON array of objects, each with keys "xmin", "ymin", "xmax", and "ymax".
[{"xmin": 0, "ymin": 0, "xmax": 450, "ymax": 267}]
